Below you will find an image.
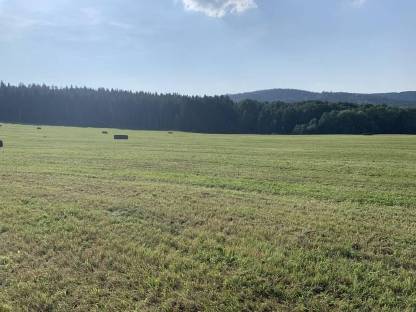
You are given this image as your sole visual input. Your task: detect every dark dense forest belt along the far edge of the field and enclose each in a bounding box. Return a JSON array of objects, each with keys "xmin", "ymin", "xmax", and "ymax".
[{"xmin": 0, "ymin": 83, "xmax": 416, "ymax": 134}]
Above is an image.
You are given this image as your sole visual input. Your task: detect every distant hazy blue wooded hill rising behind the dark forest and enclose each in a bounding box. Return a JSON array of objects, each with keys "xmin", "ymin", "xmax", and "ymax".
[{"xmin": 229, "ymin": 89, "xmax": 416, "ymax": 107}]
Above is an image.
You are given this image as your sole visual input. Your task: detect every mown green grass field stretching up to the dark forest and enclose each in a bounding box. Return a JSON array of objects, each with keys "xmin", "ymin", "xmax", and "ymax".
[{"xmin": 0, "ymin": 124, "xmax": 416, "ymax": 311}]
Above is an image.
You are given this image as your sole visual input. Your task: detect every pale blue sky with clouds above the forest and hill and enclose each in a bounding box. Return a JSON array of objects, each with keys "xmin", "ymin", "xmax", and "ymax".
[{"xmin": 0, "ymin": 0, "xmax": 416, "ymax": 95}]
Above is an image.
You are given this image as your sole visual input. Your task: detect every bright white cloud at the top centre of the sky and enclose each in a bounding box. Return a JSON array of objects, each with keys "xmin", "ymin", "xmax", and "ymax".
[{"xmin": 182, "ymin": 0, "xmax": 257, "ymax": 17}]
